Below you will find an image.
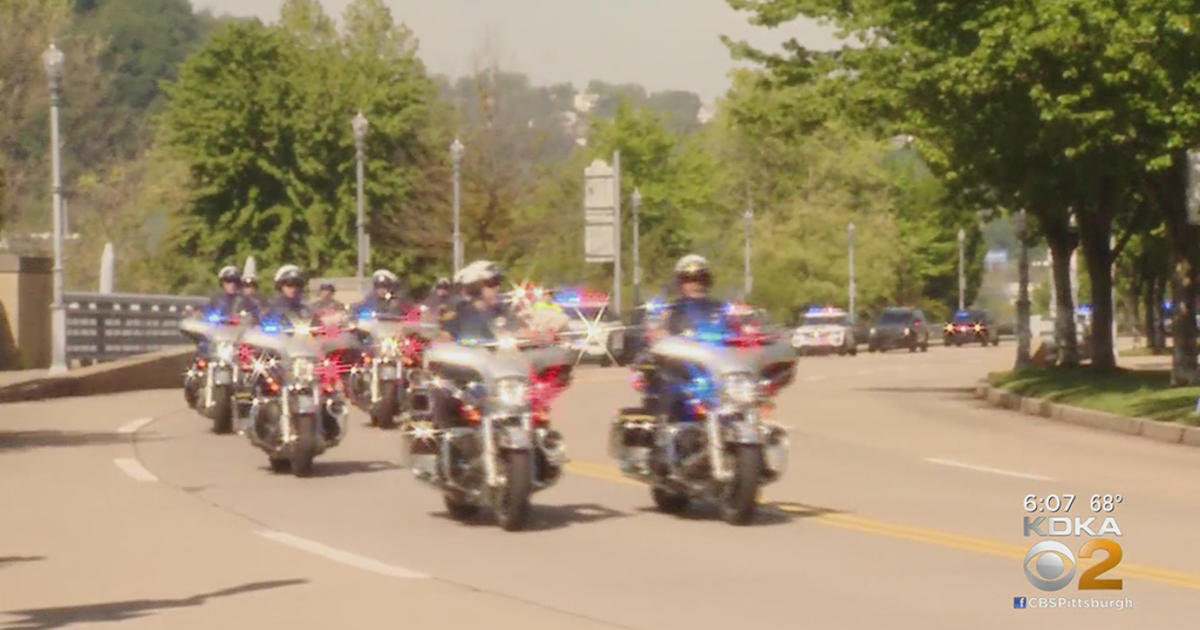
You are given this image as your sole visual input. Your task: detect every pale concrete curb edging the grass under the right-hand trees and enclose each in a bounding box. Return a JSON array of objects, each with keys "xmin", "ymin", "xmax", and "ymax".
[{"xmin": 974, "ymin": 380, "xmax": 1200, "ymax": 446}]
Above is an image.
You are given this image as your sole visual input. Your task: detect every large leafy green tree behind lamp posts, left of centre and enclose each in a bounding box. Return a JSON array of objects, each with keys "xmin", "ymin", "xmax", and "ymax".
[{"xmin": 159, "ymin": 0, "xmax": 440, "ymax": 289}]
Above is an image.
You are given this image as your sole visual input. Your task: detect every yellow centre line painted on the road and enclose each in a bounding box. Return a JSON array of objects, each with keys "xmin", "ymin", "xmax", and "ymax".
[{"xmin": 566, "ymin": 461, "xmax": 1200, "ymax": 590}]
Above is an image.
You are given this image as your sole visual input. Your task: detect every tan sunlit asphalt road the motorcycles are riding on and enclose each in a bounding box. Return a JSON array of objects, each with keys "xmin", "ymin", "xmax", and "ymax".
[{"xmin": 0, "ymin": 343, "xmax": 1200, "ymax": 630}]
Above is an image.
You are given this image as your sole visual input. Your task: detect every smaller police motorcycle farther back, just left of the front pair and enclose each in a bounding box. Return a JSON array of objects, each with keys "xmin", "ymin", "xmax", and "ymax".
[{"xmin": 350, "ymin": 308, "xmax": 439, "ymax": 428}]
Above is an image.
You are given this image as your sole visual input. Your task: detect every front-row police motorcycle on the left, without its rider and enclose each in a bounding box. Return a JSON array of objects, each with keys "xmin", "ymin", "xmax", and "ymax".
[{"xmin": 404, "ymin": 328, "xmax": 571, "ymax": 532}]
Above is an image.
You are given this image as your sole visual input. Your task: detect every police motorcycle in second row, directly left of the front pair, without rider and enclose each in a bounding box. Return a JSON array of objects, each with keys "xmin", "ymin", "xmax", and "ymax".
[{"xmin": 236, "ymin": 319, "xmax": 359, "ymax": 476}]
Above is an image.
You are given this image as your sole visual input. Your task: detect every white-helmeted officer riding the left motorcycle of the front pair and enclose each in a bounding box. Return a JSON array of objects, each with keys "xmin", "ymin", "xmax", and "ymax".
[{"xmin": 442, "ymin": 260, "xmax": 521, "ymax": 341}]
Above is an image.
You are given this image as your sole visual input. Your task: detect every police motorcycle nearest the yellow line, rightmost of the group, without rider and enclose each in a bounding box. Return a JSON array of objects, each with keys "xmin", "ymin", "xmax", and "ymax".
[{"xmin": 608, "ymin": 307, "xmax": 796, "ymax": 524}]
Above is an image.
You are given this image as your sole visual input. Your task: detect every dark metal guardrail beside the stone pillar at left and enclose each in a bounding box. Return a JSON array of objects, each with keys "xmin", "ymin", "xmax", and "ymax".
[{"xmin": 62, "ymin": 293, "xmax": 209, "ymax": 361}]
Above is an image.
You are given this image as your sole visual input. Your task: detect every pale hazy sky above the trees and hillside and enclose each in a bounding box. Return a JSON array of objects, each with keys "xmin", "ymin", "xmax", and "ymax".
[{"xmin": 192, "ymin": 0, "xmax": 839, "ymax": 102}]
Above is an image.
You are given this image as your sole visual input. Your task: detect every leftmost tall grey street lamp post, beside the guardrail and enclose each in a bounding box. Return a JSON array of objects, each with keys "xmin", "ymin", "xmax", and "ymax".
[{"xmin": 42, "ymin": 43, "xmax": 67, "ymax": 373}]
